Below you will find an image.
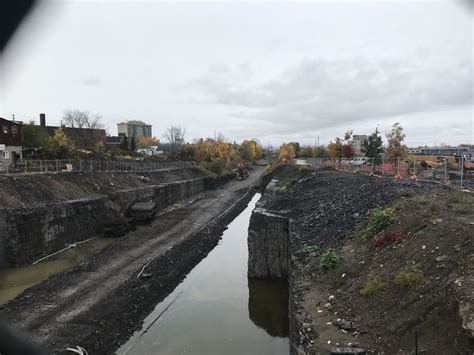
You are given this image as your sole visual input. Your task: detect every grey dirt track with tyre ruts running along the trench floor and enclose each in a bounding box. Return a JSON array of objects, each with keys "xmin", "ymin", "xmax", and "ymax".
[{"xmin": 0, "ymin": 168, "xmax": 262, "ymax": 354}]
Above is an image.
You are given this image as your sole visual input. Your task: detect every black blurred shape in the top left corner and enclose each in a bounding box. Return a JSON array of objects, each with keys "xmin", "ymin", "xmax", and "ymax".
[{"xmin": 0, "ymin": 0, "xmax": 36, "ymax": 53}]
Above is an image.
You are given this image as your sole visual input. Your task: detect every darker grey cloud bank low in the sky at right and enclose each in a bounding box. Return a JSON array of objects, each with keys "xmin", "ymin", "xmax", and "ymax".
[{"xmin": 187, "ymin": 57, "xmax": 473, "ymax": 134}]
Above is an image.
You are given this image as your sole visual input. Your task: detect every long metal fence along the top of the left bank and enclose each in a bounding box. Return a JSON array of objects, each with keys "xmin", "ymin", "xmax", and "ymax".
[{"xmin": 0, "ymin": 159, "xmax": 191, "ymax": 174}]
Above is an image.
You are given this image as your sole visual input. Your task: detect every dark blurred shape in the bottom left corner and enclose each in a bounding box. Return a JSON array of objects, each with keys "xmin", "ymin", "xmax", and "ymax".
[{"xmin": 0, "ymin": 322, "xmax": 48, "ymax": 355}]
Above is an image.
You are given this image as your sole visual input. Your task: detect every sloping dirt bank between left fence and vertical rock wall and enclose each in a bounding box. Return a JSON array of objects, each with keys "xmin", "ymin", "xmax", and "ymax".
[{"xmin": 0, "ymin": 169, "xmax": 203, "ymax": 208}]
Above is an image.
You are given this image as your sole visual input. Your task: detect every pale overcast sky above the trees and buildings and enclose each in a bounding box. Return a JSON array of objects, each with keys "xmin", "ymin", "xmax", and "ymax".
[{"xmin": 0, "ymin": 0, "xmax": 474, "ymax": 145}]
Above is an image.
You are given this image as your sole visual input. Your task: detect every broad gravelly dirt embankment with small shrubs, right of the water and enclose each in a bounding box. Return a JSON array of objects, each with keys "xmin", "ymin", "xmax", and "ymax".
[{"xmin": 260, "ymin": 171, "xmax": 474, "ymax": 354}]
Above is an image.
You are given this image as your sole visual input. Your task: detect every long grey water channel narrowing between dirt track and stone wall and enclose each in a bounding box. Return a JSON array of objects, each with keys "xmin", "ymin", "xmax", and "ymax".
[{"xmin": 117, "ymin": 195, "xmax": 289, "ymax": 355}]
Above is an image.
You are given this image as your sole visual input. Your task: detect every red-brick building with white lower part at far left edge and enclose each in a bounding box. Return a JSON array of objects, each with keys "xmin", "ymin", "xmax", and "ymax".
[{"xmin": 0, "ymin": 117, "xmax": 23, "ymax": 165}]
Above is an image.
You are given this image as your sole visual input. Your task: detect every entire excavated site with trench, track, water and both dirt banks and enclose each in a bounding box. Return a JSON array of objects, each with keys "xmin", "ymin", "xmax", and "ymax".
[{"xmin": 0, "ymin": 163, "xmax": 474, "ymax": 354}]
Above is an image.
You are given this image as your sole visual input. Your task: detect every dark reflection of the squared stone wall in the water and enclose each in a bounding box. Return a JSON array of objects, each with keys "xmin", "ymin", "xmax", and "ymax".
[{"xmin": 248, "ymin": 278, "xmax": 289, "ymax": 338}]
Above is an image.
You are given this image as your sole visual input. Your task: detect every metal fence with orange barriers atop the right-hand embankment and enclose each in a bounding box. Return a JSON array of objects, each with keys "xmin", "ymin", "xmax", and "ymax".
[{"xmin": 304, "ymin": 156, "xmax": 474, "ymax": 189}]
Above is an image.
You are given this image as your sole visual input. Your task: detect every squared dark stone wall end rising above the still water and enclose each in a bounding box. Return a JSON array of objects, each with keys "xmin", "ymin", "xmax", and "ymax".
[{"xmin": 248, "ymin": 207, "xmax": 289, "ymax": 278}]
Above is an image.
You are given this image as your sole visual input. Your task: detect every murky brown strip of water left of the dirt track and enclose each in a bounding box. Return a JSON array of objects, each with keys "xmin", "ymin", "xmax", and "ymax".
[{"xmin": 0, "ymin": 238, "xmax": 113, "ymax": 304}]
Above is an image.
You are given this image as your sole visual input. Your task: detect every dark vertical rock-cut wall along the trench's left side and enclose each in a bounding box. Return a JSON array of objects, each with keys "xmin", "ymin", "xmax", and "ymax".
[{"xmin": 0, "ymin": 173, "xmax": 231, "ymax": 266}]
